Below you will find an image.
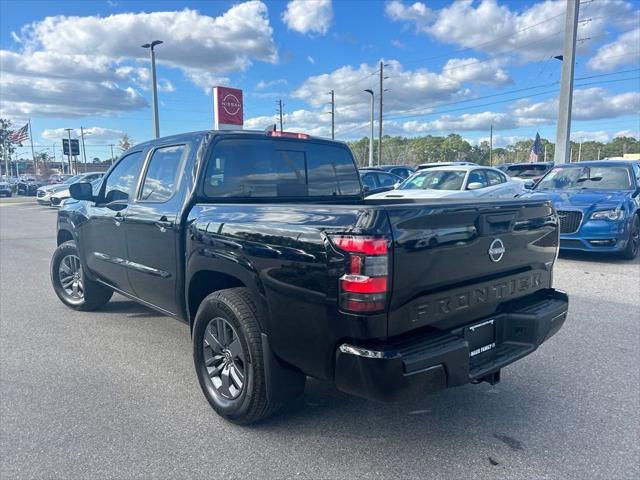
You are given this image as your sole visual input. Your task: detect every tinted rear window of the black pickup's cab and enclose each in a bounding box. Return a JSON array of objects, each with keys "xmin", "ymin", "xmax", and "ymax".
[{"xmin": 204, "ymin": 138, "xmax": 360, "ymax": 198}]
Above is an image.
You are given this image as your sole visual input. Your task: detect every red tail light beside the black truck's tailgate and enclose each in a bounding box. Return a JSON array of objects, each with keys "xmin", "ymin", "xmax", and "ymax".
[{"xmin": 330, "ymin": 235, "xmax": 389, "ymax": 313}]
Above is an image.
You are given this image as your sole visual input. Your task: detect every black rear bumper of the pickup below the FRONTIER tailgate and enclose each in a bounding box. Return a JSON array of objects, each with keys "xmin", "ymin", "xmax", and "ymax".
[{"xmin": 335, "ymin": 289, "xmax": 569, "ymax": 401}]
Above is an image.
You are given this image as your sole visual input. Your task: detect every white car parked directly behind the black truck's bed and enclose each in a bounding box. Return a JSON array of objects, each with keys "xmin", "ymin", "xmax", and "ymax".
[{"xmin": 367, "ymin": 165, "xmax": 527, "ymax": 199}]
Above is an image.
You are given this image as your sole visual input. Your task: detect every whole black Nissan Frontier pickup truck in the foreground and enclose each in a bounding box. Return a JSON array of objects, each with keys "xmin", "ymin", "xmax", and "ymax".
[{"xmin": 51, "ymin": 131, "xmax": 568, "ymax": 424}]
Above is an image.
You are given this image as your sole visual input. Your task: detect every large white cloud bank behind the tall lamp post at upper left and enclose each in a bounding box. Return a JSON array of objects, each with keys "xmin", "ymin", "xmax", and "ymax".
[{"xmin": 0, "ymin": 0, "xmax": 278, "ymax": 117}]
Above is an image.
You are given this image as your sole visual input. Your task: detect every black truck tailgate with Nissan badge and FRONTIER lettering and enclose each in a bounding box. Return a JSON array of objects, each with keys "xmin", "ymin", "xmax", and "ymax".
[{"xmin": 379, "ymin": 199, "xmax": 558, "ymax": 336}]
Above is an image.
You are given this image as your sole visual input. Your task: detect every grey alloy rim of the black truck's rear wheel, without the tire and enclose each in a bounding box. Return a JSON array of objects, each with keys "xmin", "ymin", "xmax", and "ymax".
[{"xmin": 202, "ymin": 317, "xmax": 246, "ymax": 400}]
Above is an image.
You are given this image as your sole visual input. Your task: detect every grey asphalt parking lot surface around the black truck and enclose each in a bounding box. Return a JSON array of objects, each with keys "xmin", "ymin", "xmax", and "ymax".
[{"xmin": 0, "ymin": 199, "xmax": 640, "ymax": 480}]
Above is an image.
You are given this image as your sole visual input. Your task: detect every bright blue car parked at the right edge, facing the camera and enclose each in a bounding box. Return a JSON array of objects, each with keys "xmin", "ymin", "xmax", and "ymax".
[{"xmin": 526, "ymin": 160, "xmax": 640, "ymax": 259}]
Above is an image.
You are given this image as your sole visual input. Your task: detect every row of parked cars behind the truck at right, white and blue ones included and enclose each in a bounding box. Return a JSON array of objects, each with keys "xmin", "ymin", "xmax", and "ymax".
[{"xmin": 360, "ymin": 160, "xmax": 640, "ymax": 259}]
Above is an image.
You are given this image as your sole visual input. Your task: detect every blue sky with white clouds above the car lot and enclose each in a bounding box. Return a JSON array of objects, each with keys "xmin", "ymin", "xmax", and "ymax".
[{"xmin": 0, "ymin": 0, "xmax": 640, "ymax": 158}]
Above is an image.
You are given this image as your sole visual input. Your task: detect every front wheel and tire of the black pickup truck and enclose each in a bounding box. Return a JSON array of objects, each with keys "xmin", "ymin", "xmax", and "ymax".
[{"xmin": 51, "ymin": 240, "xmax": 113, "ymax": 311}]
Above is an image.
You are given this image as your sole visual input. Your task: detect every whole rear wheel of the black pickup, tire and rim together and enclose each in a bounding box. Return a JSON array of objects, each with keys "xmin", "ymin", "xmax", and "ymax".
[{"xmin": 192, "ymin": 288, "xmax": 279, "ymax": 425}]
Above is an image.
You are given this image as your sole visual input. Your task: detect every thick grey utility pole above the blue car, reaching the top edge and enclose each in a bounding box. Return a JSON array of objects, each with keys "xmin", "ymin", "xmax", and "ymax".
[{"xmin": 554, "ymin": 0, "xmax": 580, "ymax": 163}]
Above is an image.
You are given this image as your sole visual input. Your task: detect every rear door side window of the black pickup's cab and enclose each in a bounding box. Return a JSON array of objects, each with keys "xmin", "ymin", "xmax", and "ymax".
[{"xmin": 140, "ymin": 145, "xmax": 187, "ymax": 202}]
